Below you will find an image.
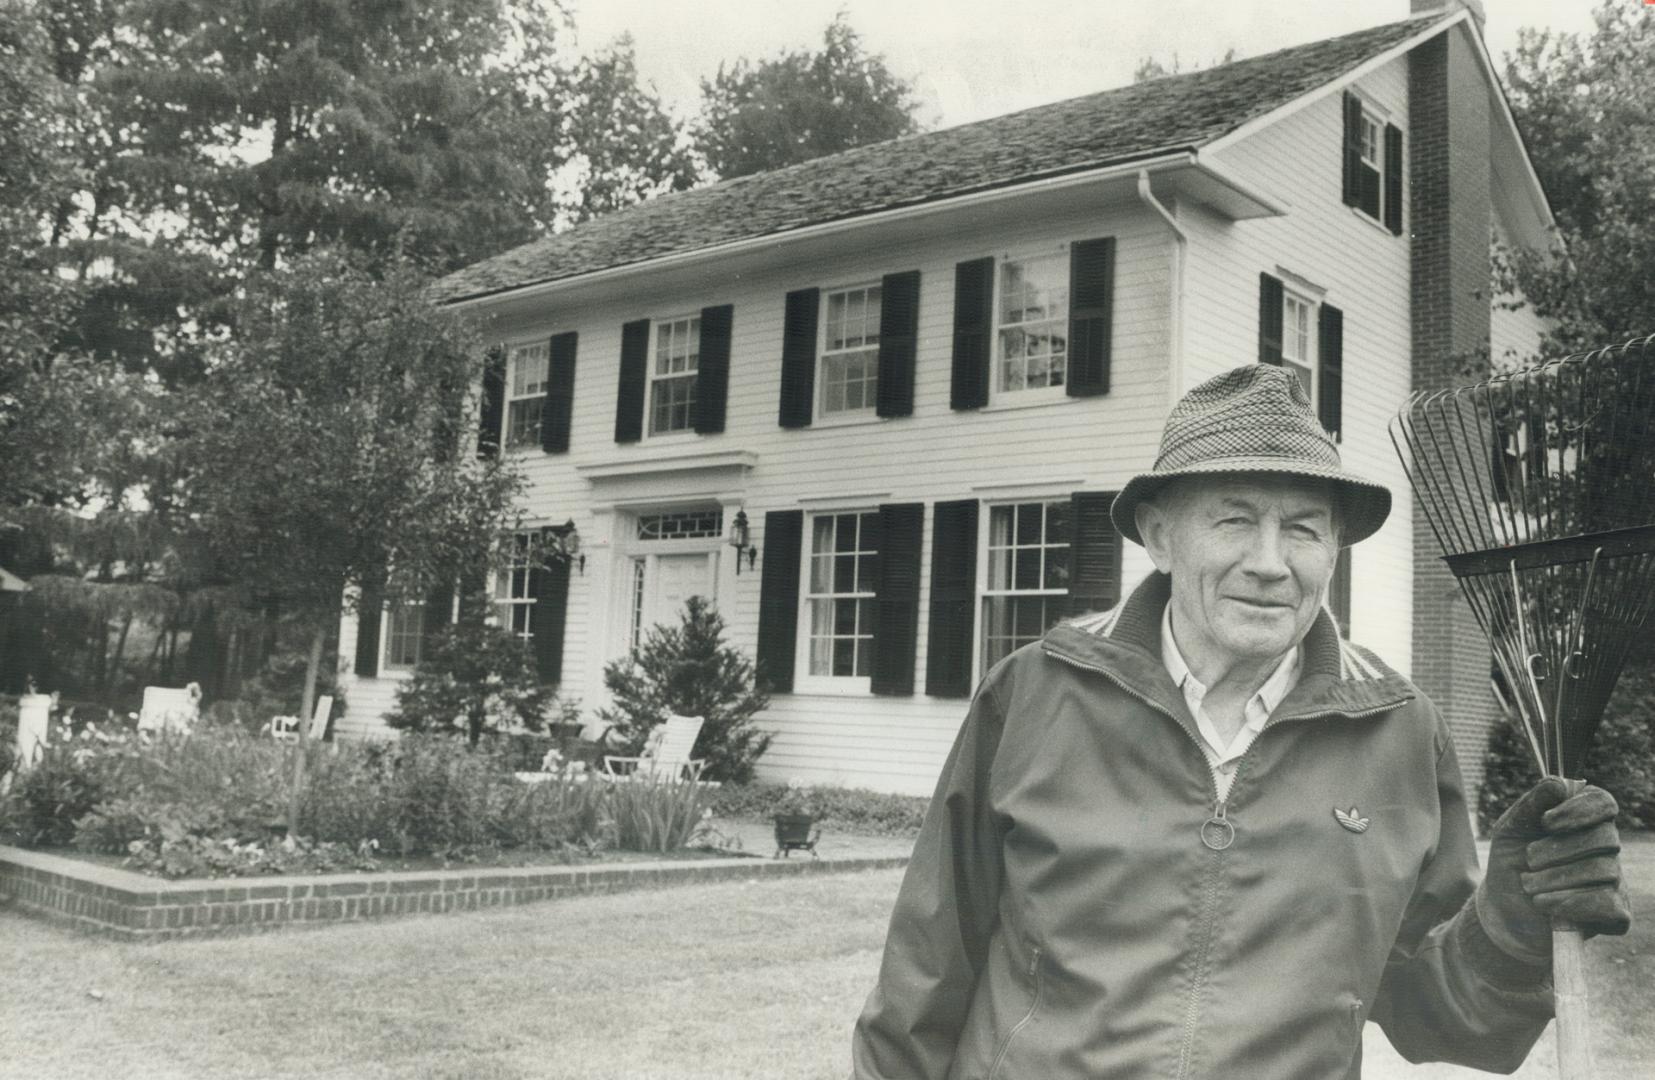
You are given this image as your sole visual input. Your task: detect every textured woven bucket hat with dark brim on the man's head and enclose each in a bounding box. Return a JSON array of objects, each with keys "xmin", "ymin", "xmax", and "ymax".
[{"xmin": 1109, "ymin": 364, "xmax": 1390, "ymax": 544}]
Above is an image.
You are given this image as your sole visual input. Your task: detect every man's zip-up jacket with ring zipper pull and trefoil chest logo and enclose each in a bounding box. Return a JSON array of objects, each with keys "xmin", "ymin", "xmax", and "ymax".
[{"xmin": 852, "ymin": 574, "xmax": 1552, "ymax": 1080}]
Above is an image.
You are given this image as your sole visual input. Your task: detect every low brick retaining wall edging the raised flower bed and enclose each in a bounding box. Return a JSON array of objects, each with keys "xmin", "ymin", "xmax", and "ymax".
[{"xmin": 0, "ymin": 845, "xmax": 907, "ymax": 941}]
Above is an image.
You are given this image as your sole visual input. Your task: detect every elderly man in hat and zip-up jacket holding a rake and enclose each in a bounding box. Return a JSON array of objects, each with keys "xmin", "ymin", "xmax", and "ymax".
[{"xmin": 852, "ymin": 366, "xmax": 1630, "ymax": 1080}]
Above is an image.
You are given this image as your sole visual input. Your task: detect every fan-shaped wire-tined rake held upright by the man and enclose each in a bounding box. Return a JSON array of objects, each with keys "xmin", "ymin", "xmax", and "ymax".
[{"xmin": 1390, "ymin": 336, "xmax": 1655, "ymax": 1080}]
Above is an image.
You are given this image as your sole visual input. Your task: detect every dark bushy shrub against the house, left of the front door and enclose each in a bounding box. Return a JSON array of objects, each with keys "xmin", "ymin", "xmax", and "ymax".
[{"xmin": 386, "ymin": 611, "xmax": 556, "ymax": 746}]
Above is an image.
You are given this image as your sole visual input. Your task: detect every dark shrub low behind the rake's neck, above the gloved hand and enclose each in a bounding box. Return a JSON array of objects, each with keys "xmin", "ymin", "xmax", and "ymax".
[{"xmin": 1478, "ymin": 665, "xmax": 1655, "ymax": 832}]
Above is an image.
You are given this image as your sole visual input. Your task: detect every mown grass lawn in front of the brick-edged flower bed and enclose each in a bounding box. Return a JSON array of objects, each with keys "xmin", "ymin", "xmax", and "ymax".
[{"xmin": 0, "ymin": 842, "xmax": 1655, "ymax": 1080}]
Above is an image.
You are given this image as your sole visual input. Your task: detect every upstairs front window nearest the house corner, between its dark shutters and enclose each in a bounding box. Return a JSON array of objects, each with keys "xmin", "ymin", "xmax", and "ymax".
[{"xmin": 995, "ymin": 250, "xmax": 1069, "ymax": 394}]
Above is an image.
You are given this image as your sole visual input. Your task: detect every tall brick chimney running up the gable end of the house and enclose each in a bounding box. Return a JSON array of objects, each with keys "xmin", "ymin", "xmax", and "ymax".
[{"xmin": 1408, "ymin": 21, "xmax": 1501, "ymax": 810}]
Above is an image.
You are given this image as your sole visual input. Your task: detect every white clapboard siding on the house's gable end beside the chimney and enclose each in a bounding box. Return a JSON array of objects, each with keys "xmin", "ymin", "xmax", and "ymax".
[{"xmin": 1180, "ymin": 58, "xmax": 1413, "ymax": 673}]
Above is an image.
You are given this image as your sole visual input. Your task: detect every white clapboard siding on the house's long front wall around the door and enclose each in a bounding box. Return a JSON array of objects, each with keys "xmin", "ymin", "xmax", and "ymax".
[{"xmin": 341, "ymin": 200, "xmax": 1172, "ymax": 792}]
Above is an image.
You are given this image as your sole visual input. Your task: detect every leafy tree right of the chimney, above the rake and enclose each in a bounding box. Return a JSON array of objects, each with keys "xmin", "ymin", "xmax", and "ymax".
[{"xmin": 1496, "ymin": 0, "xmax": 1655, "ymax": 356}]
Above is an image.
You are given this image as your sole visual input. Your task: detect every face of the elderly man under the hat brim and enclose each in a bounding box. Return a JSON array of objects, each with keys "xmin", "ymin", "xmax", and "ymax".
[{"xmin": 1139, "ymin": 476, "xmax": 1339, "ymax": 663}]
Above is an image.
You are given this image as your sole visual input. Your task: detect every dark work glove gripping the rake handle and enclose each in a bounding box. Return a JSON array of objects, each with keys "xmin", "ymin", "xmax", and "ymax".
[{"xmin": 1475, "ymin": 777, "xmax": 1632, "ymax": 966}]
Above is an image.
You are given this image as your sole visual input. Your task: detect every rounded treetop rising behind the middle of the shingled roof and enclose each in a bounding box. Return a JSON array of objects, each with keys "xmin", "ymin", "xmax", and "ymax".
[{"xmin": 697, "ymin": 12, "xmax": 920, "ymax": 180}]
